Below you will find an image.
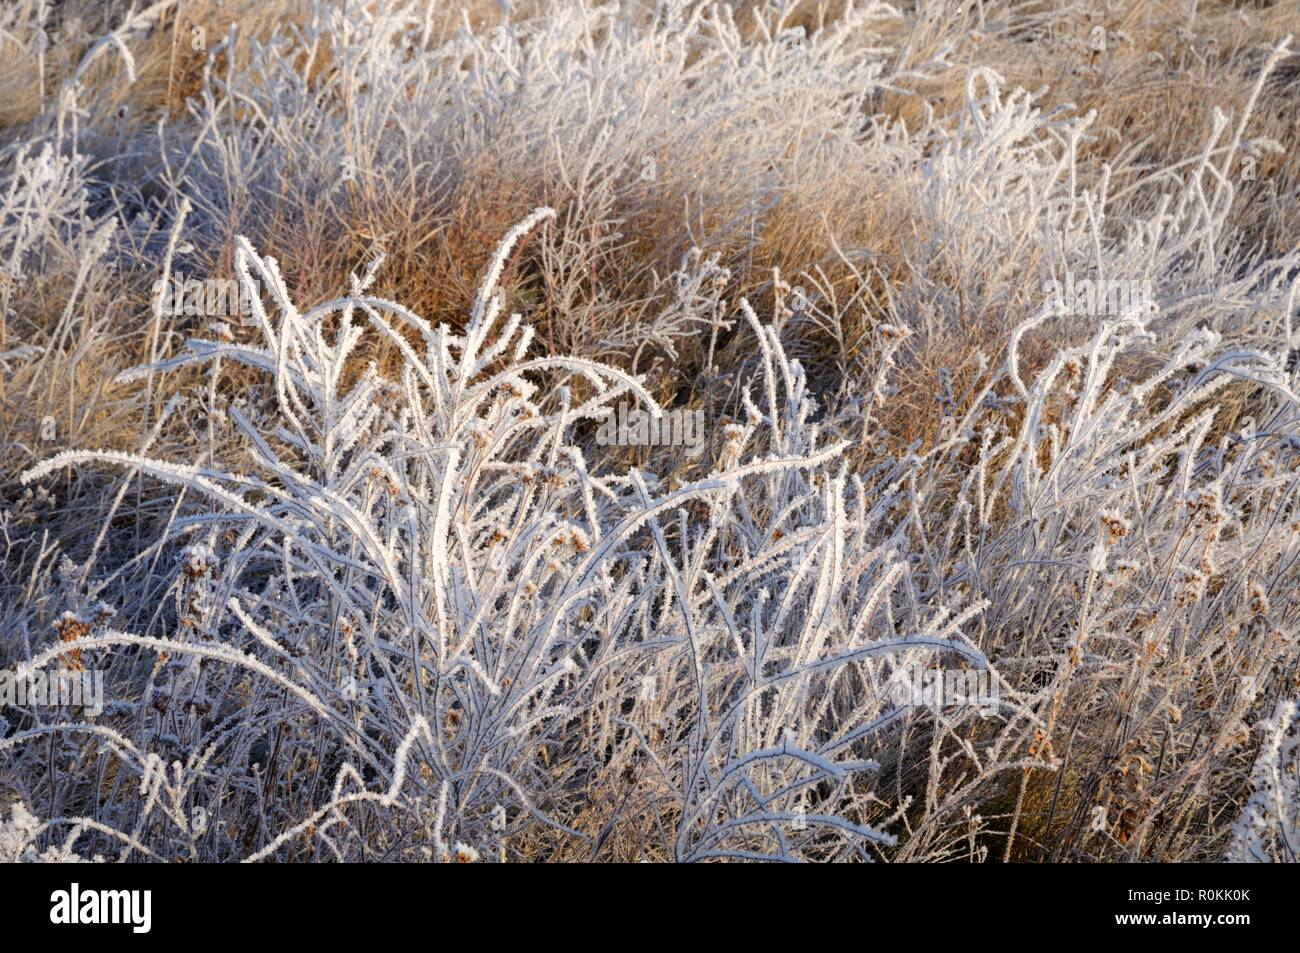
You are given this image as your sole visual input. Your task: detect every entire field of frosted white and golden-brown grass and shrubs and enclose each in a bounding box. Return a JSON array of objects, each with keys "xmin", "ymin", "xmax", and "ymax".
[{"xmin": 0, "ymin": 0, "xmax": 1300, "ymax": 861}]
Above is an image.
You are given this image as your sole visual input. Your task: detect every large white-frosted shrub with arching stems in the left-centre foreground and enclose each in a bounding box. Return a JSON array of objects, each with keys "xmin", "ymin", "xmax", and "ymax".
[{"xmin": 8, "ymin": 209, "xmax": 985, "ymax": 859}]
